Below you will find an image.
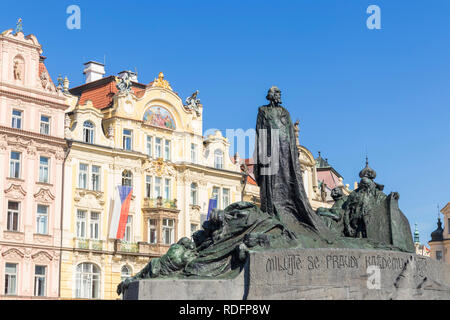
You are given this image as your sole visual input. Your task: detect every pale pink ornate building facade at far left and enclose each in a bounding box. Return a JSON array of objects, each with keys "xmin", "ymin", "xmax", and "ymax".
[{"xmin": 0, "ymin": 29, "xmax": 67, "ymax": 299}]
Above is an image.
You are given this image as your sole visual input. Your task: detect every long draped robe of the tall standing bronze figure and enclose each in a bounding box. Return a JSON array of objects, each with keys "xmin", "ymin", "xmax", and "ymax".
[{"xmin": 254, "ymin": 105, "xmax": 329, "ymax": 236}]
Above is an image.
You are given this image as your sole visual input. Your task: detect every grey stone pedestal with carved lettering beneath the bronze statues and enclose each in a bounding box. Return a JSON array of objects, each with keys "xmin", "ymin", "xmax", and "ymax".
[{"xmin": 124, "ymin": 249, "xmax": 450, "ymax": 300}]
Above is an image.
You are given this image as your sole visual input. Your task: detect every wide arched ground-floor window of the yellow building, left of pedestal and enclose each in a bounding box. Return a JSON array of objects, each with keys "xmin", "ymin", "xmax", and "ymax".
[{"xmin": 75, "ymin": 263, "xmax": 100, "ymax": 299}]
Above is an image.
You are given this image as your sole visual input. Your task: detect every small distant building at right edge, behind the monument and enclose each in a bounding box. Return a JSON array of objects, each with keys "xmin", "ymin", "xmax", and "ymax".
[{"xmin": 428, "ymin": 202, "xmax": 450, "ymax": 264}]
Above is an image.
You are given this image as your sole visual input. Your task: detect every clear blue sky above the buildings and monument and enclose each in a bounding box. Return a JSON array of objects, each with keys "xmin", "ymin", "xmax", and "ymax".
[{"xmin": 0, "ymin": 0, "xmax": 450, "ymax": 242}]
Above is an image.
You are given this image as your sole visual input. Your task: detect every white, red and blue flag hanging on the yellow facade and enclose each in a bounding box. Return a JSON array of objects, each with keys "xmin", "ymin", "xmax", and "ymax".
[{"xmin": 109, "ymin": 186, "xmax": 133, "ymax": 239}]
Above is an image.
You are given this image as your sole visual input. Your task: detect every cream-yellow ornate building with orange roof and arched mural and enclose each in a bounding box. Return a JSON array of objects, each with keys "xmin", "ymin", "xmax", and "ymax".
[{"xmin": 61, "ymin": 61, "xmax": 242, "ymax": 299}]
